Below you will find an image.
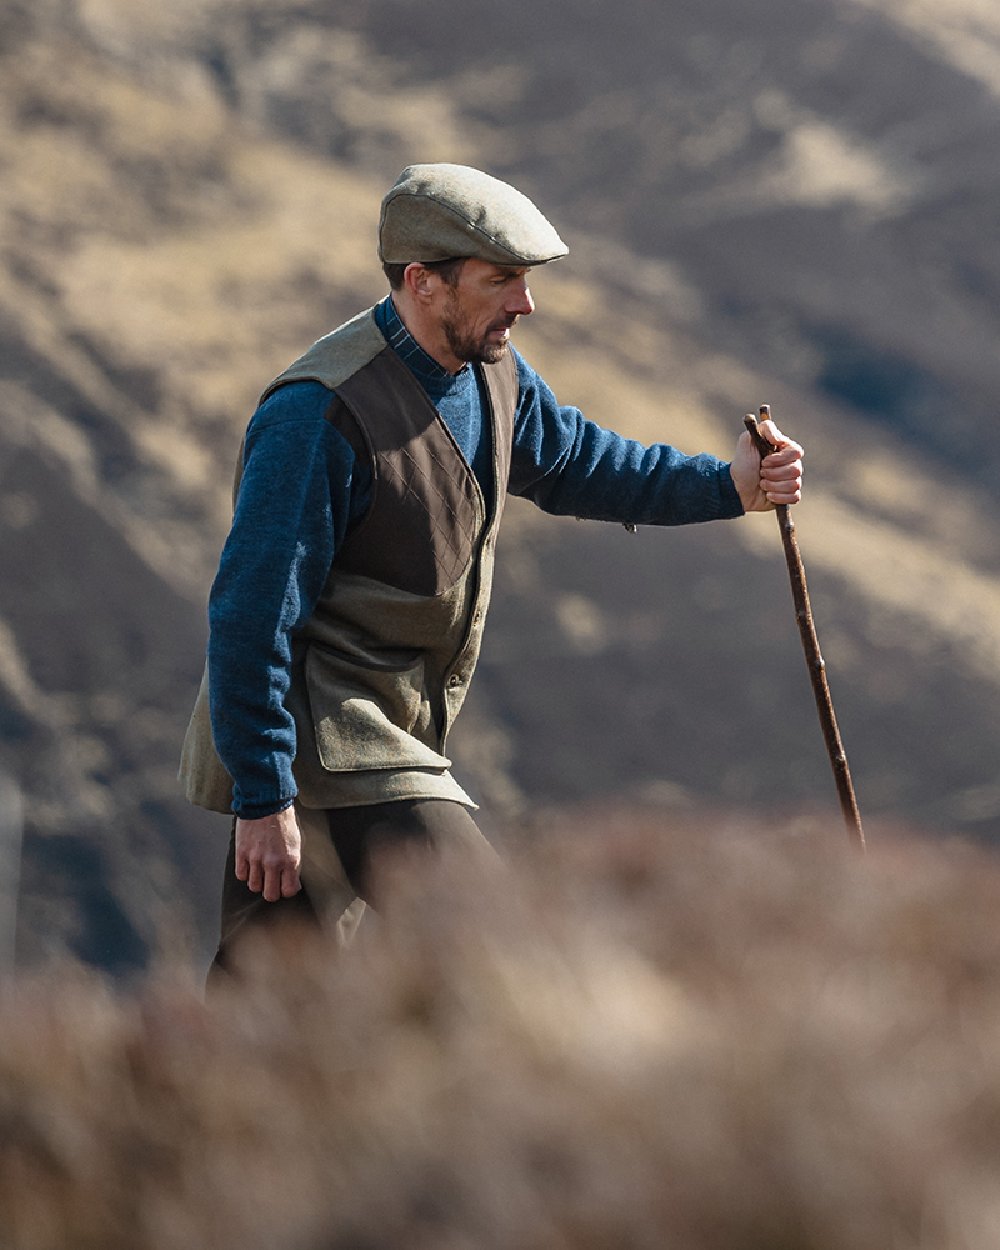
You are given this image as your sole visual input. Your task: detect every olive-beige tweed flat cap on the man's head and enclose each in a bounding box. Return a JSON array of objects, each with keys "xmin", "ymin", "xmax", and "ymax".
[{"xmin": 379, "ymin": 165, "xmax": 569, "ymax": 265}]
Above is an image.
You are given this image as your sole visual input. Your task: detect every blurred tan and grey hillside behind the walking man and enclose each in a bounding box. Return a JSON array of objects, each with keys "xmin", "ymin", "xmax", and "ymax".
[{"xmin": 0, "ymin": 0, "xmax": 1000, "ymax": 970}]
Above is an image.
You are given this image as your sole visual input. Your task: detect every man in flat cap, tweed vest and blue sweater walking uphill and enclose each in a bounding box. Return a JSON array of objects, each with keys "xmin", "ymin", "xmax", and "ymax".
[{"xmin": 181, "ymin": 165, "xmax": 801, "ymax": 966}]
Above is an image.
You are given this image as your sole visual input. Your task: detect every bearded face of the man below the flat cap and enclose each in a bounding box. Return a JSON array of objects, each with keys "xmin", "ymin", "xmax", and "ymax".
[{"xmin": 440, "ymin": 259, "xmax": 535, "ymax": 365}]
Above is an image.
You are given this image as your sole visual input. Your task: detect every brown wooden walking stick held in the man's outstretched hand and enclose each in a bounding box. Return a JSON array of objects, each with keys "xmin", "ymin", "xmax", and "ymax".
[{"xmin": 744, "ymin": 404, "xmax": 865, "ymax": 851}]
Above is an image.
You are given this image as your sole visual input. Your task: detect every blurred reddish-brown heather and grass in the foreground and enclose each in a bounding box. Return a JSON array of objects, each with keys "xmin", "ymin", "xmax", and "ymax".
[{"xmin": 0, "ymin": 813, "xmax": 1000, "ymax": 1250}]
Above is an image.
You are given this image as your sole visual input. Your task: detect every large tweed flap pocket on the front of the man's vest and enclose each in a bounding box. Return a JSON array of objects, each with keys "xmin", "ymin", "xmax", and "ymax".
[{"xmin": 305, "ymin": 643, "xmax": 451, "ymax": 773}]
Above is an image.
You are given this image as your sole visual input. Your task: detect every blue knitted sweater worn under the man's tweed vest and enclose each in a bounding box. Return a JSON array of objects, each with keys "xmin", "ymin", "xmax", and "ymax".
[{"xmin": 209, "ymin": 298, "xmax": 743, "ymax": 818}]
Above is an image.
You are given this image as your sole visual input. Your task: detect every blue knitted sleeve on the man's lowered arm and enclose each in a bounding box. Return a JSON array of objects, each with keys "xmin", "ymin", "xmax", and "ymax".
[{"xmin": 209, "ymin": 383, "xmax": 370, "ymax": 818}]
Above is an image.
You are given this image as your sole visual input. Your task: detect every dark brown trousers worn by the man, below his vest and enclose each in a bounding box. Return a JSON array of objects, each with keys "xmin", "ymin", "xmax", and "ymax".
[{"xmin": 209, "ymin": 799, "xmax": 488, "ymax": 985}]
